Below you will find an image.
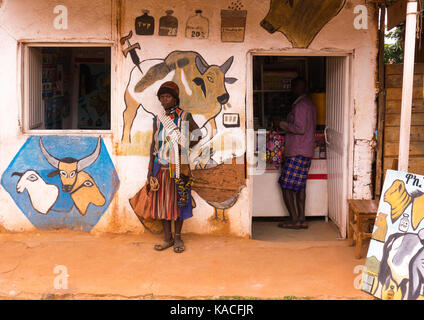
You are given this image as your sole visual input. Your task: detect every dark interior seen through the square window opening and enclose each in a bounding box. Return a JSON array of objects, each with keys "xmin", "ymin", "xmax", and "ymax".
[{"xmin": 39, "ymin": 47, "xmax": 111, "ymax": 130}]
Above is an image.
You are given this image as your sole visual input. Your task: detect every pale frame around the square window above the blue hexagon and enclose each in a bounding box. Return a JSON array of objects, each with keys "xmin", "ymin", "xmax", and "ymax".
[{"xmin": 18, "ymin": 41, "xmax": 117, "ymax": 136}]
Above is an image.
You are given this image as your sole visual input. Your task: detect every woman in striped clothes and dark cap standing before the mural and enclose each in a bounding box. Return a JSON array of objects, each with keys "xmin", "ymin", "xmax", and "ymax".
[{"xmin": 147, "ymin": 81, "xmax": 199, "ymax": 253}]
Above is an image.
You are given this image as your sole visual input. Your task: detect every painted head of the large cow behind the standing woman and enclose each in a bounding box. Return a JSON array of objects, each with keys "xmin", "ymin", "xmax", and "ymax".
[{"xmin": 193, "ymin": 56, "xmax": 237, "ymax": 105}]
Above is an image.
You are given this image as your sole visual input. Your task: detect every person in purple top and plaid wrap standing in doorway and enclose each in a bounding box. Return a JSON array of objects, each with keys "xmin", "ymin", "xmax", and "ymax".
[{"xmin": 275, "ymin": 78, "xmax": 317, "ymax": 229}]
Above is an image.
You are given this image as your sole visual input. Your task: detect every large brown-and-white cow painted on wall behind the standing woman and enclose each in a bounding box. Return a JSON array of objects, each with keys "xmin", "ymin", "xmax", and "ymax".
[{"xmin": 122, "ymin": 51, "xmax": 237, "ymax": 143}]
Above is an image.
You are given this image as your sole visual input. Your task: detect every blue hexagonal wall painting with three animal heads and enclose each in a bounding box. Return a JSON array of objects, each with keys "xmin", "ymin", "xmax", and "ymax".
[{"xmin": 1, "ymin": 136, "xmax": 119, "ymax": 231}]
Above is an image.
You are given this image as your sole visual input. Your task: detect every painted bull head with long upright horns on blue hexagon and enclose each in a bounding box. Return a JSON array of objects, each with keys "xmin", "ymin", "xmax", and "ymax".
[{"xmin": 40, "ymin": 137, "xmax": 101, "ymax": 193}]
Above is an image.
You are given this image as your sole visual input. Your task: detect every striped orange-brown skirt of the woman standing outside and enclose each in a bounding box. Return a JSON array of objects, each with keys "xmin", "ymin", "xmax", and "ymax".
[{"xmin": 150, "ymin": 163, "xmax": 193, "ymax": 220}]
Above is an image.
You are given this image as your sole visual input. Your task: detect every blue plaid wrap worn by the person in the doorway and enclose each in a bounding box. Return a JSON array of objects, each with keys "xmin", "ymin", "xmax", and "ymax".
[{"xmin": 278, "ymin": 156, "xmax": 311, "ymax": 192}]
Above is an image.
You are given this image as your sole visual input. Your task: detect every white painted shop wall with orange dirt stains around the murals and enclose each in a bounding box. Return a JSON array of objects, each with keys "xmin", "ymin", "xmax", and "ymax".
[{"xmin": 0, "ymin": 0, "xmax": 377, "ymax": 236}]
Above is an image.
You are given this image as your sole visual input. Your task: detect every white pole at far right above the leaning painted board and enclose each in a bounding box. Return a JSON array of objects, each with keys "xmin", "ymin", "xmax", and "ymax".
[{"xmin": 398, "ymin": 0, "xmax": 417, "ymax": 172}]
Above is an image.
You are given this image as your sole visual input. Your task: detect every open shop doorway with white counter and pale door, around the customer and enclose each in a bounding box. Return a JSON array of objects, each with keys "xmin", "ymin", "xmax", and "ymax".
[{"xmin": 251, "ymin": 55, "xmax": 350, "ymax": 240}]
